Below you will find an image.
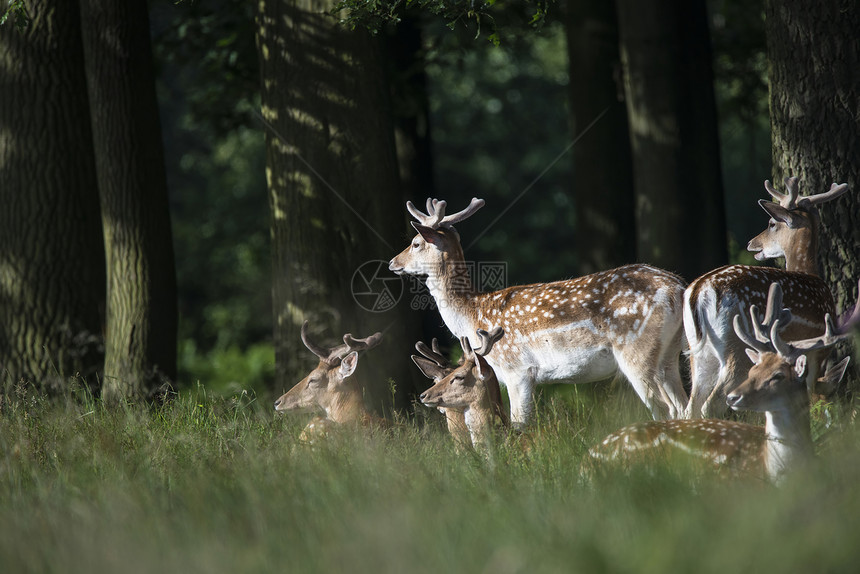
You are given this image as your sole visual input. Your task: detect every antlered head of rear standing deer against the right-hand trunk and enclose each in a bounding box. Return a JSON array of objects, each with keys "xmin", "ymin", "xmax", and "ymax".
[{"xmin": 747, "ymin": 177, "xmax": 848, "ymax": 274}]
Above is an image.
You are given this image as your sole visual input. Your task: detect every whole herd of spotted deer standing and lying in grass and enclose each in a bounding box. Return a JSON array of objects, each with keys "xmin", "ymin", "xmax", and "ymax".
[{"xmin": 275, "ymin": 178, "xmax": 860, "ymax": 482}]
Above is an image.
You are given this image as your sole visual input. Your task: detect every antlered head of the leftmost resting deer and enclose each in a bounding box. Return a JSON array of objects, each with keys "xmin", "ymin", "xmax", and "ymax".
[{"xmin": 275, "ymin": 321, "xmax": 382, "ymax": 422}]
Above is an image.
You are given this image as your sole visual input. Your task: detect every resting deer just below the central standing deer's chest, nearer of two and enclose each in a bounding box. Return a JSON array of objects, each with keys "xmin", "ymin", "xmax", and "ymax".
[{"xmin": 413, "ymin": 327, "xmax": 509, "ymax": 450}]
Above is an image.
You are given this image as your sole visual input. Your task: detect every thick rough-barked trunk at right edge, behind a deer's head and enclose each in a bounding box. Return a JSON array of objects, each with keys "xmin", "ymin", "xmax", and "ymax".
[{"xmin": 765, "ymin": 0, "xmax": 860, "ymax": 318}]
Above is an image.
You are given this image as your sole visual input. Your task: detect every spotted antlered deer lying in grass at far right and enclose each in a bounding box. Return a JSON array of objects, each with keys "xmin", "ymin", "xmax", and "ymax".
[{"xmin": 589, "ymin": 283, "xmax": 860, "ymax": 482}]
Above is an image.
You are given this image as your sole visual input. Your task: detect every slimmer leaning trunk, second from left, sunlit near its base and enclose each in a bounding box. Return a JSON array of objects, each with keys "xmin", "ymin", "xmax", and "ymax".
[{"xmin": 80, "ymin": 0, "xmax": 177, "ymax": 400}]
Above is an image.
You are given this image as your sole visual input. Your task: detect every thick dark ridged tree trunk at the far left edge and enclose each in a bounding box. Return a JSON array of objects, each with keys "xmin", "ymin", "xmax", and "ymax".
[{"xmin": 0, "ymin": 0, "xmax": 104, "ymax": 390}]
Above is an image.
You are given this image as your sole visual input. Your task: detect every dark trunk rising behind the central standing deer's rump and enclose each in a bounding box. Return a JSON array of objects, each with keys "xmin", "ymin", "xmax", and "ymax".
[{"xmin": 617, "ymin": 0, "xmax": 727, "ymax": 280}]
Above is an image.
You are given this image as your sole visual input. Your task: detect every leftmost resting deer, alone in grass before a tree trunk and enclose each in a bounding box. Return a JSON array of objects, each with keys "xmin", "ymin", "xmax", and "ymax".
[{"xmin": 275, "ymin": 321, "xmax": 385, "ymax": 443}]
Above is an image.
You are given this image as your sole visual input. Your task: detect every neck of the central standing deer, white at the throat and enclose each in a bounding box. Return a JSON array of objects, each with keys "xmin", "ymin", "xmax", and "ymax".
[{"xmin": 427, "ymin": 252, "xmax": 477, "ymax": 337}]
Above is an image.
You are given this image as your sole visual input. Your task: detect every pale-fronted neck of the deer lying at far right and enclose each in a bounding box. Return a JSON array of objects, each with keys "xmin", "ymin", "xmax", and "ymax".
[{"xmin": 765, "ymin": 405, "xmax": 813, "ymax": 482}]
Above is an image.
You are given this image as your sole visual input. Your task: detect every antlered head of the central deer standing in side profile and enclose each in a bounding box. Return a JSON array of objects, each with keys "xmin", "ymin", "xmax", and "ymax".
[{"xmin": 388, "ymin": 197, "xmax": 484, "ymax": 276}]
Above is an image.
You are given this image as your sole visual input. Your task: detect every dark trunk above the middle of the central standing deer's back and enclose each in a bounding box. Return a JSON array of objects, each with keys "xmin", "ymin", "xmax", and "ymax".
[{"xmin": 565, "ymin": 0, "xmax": 636, "ymax": 275}]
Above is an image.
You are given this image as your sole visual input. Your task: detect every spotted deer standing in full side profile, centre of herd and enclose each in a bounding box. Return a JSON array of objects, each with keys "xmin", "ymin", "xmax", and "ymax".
[{"xmin": 389, "ymin": 199, "xmax": 687, "ymax": 427}]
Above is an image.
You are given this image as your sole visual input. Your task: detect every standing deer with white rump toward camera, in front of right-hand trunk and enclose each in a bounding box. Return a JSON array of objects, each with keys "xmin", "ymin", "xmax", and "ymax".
[{"xmin": 684, "ymin": 178, "xmax": 848, "ymax": 418}]
